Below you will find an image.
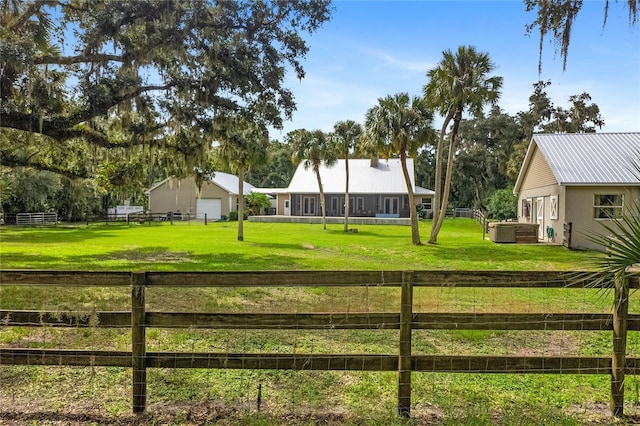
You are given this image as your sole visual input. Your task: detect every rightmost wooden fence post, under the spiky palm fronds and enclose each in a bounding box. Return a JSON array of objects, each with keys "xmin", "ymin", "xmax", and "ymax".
[{"xmin": 611, "ymin": 276, "xmax": 629, "ymax": 417}]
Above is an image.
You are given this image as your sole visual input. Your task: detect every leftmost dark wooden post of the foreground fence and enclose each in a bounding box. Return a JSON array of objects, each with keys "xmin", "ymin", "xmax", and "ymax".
[{"xmin": 131, "ymin": 272, "xmax": 147, "ymax": 414}]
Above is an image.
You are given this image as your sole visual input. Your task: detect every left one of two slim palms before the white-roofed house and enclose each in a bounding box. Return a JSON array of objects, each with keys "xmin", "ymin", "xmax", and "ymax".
[{"xmin": 287, "ymin": 129, "xmax": 336, "ymax": 229}]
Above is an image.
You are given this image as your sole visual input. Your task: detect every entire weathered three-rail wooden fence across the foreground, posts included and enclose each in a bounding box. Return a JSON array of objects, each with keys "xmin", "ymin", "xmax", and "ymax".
[{"xmin": 0, "ymin": 270, "xmax": 640, "ymax": 416}]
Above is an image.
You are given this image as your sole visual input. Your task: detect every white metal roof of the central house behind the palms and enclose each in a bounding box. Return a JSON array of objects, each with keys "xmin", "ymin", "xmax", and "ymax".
[{"xmin": 288, "ymin": 158, "xmax": 416, "ymax": 194}]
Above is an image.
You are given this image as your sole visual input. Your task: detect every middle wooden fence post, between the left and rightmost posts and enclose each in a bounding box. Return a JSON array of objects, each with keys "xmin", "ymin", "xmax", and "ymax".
[{"xmin": 398, "ymin": 271, "xmax": 413, "ymax": 417}]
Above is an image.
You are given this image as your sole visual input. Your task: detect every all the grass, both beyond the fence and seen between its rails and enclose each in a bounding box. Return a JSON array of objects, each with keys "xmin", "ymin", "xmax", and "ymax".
[{"xmin": 0, "ymin": 219, "xmax": 640, "ymax": 425}]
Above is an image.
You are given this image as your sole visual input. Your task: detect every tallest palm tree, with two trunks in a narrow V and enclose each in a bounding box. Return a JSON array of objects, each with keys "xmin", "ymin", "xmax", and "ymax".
[{"xmin": 424, "ymin": 46, "xmax": 502, "ymax": 244}]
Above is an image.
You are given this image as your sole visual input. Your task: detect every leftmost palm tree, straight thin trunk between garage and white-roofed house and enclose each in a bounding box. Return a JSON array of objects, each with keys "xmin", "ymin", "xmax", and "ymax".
[{"xmin": 215, "ymin": 115, "xmax": 269, "ymax": 241}]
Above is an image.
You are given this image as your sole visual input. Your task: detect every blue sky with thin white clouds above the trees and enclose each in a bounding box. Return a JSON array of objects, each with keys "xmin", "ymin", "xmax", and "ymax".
[{"xmin": 271, "ymin": 0, "xmax": 640, "ymax": 140}]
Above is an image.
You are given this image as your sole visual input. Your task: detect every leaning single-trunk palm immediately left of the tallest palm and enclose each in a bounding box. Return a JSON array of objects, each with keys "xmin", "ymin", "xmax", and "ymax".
[{"xmin": 364, "ymin": 93, "xmax": 433, "ymax": 245}]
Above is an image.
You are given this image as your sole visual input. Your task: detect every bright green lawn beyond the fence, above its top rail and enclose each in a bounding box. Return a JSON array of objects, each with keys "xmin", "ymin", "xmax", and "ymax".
[{"xmin": 0, "ymin": 219, "xmax": 594, "ymax": 271}]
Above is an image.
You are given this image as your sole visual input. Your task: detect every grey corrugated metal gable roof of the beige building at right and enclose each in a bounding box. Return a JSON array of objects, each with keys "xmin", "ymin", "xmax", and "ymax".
[{"xmin": 513, "ymin": 133, "xmax": 640, "ymax": 193}]
